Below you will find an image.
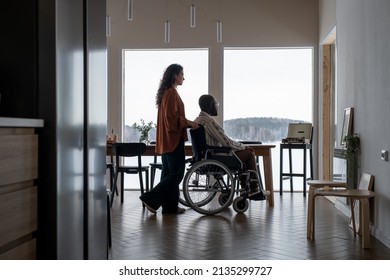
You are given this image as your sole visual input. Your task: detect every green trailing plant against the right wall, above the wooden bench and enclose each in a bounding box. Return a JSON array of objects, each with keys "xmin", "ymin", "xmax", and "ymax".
[{"xmin": 344, "ymin": 133, "xmax": 360, "ymax": 188}]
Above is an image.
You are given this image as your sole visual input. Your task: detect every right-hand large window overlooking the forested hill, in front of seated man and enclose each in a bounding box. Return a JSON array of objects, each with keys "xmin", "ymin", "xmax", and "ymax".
[{"xmin": 223, "ymin": 48, "xmax": 313, "ymax": 190}]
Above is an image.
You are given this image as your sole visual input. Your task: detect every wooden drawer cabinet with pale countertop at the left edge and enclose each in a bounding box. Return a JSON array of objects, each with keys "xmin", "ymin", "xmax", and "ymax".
[{"xmin": 0, "ymin": 118, "xmax": 43, "ymax": 259}]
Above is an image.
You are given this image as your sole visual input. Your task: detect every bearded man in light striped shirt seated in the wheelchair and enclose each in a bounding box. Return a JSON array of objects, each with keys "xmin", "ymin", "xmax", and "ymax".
[{"xmin": 195, "ymin": 94, "xmax": 269, "ymax": 199}]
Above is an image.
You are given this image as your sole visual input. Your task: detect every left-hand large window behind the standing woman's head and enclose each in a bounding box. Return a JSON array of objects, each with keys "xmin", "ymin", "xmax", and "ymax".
[{"xmin": 123, "ymin": 49, "xmax": 209, "ymax": 141}]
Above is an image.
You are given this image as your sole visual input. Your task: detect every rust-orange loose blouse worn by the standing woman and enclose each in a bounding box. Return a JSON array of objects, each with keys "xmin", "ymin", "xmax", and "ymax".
[{"xmin": 155, "ymin": 87, "xmax": 188, "ymax": 154}]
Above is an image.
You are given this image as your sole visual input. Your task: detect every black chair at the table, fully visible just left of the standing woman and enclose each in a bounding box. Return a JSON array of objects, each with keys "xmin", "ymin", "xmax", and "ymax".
[{"xmin": 111, "ymin": 143, "xmax": 149, "ymax": 205}]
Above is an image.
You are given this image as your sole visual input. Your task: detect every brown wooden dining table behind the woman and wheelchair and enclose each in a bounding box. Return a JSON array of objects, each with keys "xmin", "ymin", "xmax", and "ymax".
[{"xmin": 107, "ymin": 142, "xmax": 276, "ymax": 206}]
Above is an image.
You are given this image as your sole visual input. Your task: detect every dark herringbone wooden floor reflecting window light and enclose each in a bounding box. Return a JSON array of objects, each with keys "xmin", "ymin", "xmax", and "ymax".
[{"xmin": 109, "ymin": 191, "xmax": 390, "ymax": 260}]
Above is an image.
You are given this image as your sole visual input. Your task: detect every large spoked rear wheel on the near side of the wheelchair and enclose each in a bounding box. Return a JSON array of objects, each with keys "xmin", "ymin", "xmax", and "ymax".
[{"xmin": 183, "ymin": 160, "xmax": 235, "ymax": 215}]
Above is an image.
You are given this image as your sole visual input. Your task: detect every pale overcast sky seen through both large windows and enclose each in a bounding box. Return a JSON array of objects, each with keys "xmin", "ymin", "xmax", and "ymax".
[{"xmin": 123, "ymin": 48, "xmax": 313, "ymax": 129}]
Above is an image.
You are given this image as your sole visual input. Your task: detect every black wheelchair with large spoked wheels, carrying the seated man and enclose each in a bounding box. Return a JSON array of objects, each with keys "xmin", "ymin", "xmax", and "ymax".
[{"xmin": 181, "ymin": 126, "xmax": 266, "ymax": 215}]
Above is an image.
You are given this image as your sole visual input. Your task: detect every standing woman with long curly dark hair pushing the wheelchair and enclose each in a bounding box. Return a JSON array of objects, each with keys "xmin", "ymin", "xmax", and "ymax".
[{"xmin": 140, "ymin": 64, "xmax": 198, "ymax": 214}]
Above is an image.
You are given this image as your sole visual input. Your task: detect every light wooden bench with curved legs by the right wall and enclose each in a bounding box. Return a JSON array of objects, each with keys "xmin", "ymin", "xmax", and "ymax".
[{"xmin": 307, "ymin": 174, "xmax": 375, "ymax": 248}]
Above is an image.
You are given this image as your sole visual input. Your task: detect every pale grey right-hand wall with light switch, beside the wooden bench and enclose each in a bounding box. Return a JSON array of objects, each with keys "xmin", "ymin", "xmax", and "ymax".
[{"xmin": 320, "ymin": 0, "xmax": 390, "ymax": 247}]
